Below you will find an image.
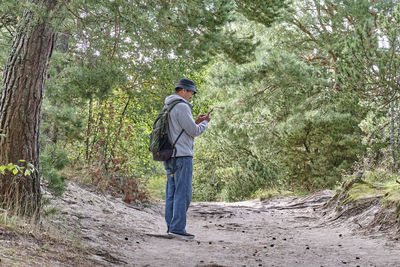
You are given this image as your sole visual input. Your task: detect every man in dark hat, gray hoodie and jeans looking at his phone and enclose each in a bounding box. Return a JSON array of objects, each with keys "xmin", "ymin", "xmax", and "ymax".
[{"xmin": 164, "ymin": 79, "xmax": 210, "ymax": 239}]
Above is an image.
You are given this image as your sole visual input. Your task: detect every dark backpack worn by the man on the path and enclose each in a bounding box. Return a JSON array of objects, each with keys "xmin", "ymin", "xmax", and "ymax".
[{"xmin": 149, "ymin": 100, "xmax": 184, "ymax": 161}]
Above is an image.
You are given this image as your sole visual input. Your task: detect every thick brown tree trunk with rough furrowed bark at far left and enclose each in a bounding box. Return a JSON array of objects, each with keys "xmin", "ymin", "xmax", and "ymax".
[{"xmin": 0, "ymin": 0, "xmax": 58, "ymax": 216}]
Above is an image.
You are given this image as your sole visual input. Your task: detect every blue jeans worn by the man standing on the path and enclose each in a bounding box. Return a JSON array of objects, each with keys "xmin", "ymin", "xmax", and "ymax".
[{"xmin": 164, "ymin": 157, "xmax": 193, "ymax": 233}]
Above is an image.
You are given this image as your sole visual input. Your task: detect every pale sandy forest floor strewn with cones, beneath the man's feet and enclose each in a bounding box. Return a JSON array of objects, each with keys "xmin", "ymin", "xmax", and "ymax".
[{"xmin": 0, "ymin": 182, "xmax": 400, "ymax": 267}]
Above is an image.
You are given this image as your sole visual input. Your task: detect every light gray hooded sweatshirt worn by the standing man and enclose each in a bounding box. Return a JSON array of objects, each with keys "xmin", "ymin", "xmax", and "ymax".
[{"xmin": 164, "ymin": 94, "xmax": 208, "ymax": 157}]
